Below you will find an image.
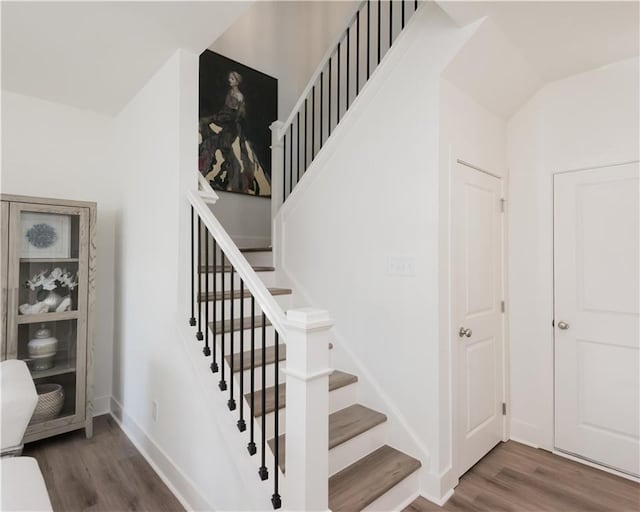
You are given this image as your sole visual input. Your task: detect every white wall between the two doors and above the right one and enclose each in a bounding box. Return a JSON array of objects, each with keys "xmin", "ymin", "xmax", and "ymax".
[{"xmin": 507, "ymin": 58, "xmax": 640, "ymax": 449}]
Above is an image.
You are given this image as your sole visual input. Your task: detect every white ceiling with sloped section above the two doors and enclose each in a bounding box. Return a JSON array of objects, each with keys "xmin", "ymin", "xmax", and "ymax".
[{"xmin": 438, "ymin": 1, "xmax": 640, "ymax": 118}]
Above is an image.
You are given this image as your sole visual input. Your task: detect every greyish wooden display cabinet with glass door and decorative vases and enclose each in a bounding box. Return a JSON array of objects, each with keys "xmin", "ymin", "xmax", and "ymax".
[{"xmin": 0, "ymin": 194, "xmax": 96, "ymax": 442}]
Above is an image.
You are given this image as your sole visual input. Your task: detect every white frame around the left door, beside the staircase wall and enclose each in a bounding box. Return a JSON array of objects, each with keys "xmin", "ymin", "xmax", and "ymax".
[{"xmin": 447, "ymin": 156, "xmax": 511, "ymax": 485}]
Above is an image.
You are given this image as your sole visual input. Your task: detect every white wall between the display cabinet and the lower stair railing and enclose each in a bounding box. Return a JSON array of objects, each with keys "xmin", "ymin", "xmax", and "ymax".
[{"xmin": 113, "ymin": 51, "xmax": 268, "ymax": 510}]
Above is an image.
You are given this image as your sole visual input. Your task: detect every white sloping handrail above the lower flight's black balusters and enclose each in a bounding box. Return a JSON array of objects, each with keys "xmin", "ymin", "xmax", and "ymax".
[{"xmin": 187, "ymin": 190, "xmax": 287, "ymax": 338}]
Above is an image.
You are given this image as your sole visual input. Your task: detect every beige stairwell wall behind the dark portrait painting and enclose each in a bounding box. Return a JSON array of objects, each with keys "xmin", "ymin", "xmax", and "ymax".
[{"xmin": 210, "ymin": 1, "xmax": 358, "ymax": 247}]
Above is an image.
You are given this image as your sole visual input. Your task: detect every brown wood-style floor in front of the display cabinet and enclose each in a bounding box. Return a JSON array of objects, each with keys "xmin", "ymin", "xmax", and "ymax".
[{"xmin": 24, "ymin": 415, "xmax": 184, "ymax": 512}]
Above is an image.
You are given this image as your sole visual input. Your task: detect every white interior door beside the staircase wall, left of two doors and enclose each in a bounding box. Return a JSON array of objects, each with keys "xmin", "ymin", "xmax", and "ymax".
[{"xmin": 451, "ymin": 163, "xmax": 503, "ymax": 475}]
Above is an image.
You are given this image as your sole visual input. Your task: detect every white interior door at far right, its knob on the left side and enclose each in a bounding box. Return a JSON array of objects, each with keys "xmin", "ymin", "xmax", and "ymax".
[{"xmin": 554, "ymin": 163, "xmax": 640, "ymax": 476}]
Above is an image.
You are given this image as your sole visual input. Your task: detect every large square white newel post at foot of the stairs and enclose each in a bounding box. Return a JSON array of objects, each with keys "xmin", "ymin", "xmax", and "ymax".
[{"xmin": 282, "ymin": 308, "xmax": 333, "ymax": 511}]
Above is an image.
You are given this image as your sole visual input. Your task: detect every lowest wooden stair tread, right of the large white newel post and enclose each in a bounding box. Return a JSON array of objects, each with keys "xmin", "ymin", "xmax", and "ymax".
[{"xmin": 329, "ymin": 445, "xmax": 421, "ymax": 512}]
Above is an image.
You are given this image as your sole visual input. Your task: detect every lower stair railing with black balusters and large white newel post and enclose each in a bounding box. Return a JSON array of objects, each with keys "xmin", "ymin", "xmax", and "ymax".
[{"xmin": 188, "ymin": 187, "xmax": 333, "ymax": 511}]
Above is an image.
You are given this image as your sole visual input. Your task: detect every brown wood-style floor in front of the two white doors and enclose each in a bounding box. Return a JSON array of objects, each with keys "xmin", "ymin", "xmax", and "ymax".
[{"xmin": 404, "ymin": 441, "xmax": 640, "ymax": 512}]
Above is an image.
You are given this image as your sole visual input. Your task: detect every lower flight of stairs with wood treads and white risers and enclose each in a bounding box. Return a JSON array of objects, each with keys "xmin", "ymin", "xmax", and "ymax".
[{"xmin": 193, "ymin": 242, "xmax": 421, "ymax": 512}]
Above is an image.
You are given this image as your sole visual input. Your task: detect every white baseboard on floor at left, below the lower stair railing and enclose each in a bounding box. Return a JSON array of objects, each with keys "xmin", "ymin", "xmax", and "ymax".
[{"xmin": 111, "ymin": 397, "xmax": 215, "ymax": 510}]
